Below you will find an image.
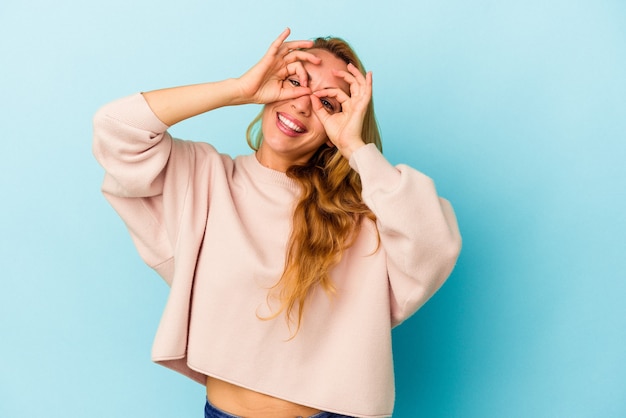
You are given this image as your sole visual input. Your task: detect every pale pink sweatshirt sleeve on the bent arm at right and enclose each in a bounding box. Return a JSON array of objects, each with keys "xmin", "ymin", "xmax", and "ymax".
[{"xmin": 350, "ymin": 144, "xmax": 461, "ymax": 326}]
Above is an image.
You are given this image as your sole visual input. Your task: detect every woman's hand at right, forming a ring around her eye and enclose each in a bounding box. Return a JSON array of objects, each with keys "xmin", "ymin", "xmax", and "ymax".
[{"xmin": 311, "ymin": 64, "xmax": 372, "ymax": 159}]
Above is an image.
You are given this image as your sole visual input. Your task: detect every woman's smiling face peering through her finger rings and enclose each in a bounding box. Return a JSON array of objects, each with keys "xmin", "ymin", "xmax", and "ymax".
[{"xmin": 257, "ymin": 49, "xmax": 350, "ymax": 171}]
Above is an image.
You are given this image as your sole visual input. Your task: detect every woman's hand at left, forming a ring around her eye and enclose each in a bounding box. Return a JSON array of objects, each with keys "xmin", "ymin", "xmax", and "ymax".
[{"xmin": 236, "ymin": 28, "xmax": 321, "ymax": 104}]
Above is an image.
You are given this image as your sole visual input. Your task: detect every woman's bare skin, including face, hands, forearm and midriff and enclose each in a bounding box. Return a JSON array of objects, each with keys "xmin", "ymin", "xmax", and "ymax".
[{"xmin": 144, "ymin": 29, "xmax": 372, "ymax": 418}]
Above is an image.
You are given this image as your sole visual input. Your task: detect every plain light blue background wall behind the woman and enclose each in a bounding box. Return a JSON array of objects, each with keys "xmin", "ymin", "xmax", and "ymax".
[{"xmin": 0, "ymin": 0, "xmax": 626, "ymax": 418}]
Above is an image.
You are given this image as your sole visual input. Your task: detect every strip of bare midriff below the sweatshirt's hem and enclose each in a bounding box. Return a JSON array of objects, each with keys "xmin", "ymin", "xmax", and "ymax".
[{"xmin": 206, "ymin": 376, "xmax": 321, "ymax": 418}]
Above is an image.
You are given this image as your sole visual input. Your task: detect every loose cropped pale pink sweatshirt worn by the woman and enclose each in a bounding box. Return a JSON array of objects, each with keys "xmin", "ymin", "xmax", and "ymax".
[{"xmin": 93, "ymin": 94, "xmax": 461, "ymax": 417}]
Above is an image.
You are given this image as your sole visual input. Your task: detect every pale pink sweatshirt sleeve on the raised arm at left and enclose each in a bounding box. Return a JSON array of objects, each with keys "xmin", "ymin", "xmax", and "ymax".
[{"xmin": 93, "ymin": 93, "xmax": 214, "ymax": 284}]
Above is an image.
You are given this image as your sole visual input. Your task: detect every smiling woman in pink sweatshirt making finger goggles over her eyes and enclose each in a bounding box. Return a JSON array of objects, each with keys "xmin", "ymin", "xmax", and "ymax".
[{"xmin": 94, "ymin": 29, "xmax": 461, "ymax": 418}]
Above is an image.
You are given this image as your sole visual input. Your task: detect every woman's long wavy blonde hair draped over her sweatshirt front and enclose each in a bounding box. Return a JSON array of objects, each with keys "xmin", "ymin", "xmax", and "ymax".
[{"xmin": 246, "ymin": 37, "xmax": 382, "ymax": 338}]
